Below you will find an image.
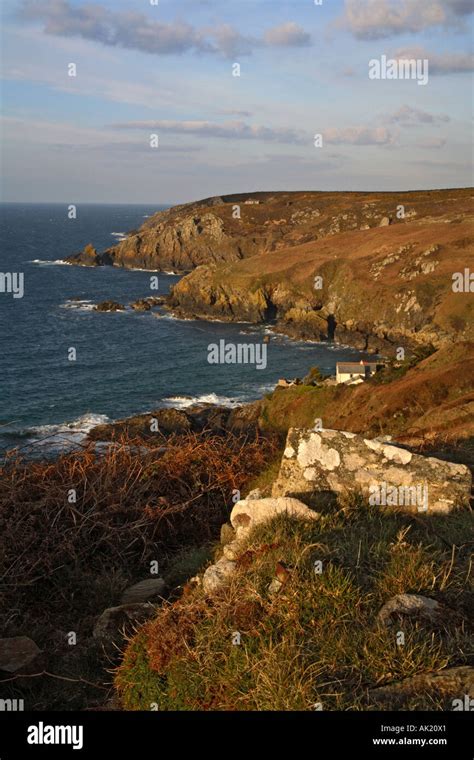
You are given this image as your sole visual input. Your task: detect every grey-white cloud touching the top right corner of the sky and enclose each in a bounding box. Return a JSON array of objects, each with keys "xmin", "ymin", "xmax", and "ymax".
[{"xmin": 337, "ymin": 0, "xmax": 474, "ymax": 40}]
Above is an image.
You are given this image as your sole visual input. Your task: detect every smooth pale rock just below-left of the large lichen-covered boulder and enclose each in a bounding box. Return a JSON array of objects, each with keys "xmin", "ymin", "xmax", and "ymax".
[{"xmin": 230, "ymin": 498, "xmax": 319, "ymax": 541}]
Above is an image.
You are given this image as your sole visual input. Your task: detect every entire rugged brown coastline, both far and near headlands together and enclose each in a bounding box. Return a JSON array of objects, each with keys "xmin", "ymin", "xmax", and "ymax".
[{"xmin": 67, "ymin": 189, "xmax": 474, "ymax": 351}]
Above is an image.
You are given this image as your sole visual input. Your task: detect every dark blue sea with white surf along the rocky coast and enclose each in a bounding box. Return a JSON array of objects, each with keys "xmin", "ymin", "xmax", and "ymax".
[{"xmin": 0, "ymin": 204, "xmax": 364, "ymax": 453}]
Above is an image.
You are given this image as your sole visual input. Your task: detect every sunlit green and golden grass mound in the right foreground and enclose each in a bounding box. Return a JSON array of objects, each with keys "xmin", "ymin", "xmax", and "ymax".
[{"xmin": 115, "ymin": 496, "xmax": 474, "ymax": 711}]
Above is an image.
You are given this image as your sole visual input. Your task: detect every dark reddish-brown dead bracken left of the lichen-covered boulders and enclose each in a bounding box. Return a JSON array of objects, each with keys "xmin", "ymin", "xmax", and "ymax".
[{"xmin": 0, "ymin": 434, "xmax": 273, "ymax": 709}]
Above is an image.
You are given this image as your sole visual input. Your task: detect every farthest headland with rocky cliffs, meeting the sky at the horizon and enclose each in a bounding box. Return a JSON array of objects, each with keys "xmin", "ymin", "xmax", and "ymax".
[{"xmin": 66, "ymin": 190, "xmax": 468, "ymax": 273}]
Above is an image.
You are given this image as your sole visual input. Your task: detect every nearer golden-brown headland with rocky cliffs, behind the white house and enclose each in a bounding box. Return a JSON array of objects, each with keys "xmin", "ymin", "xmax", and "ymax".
[{"xmin": 170, "ymin": 196, "xmax": 474, "ymax": 351}]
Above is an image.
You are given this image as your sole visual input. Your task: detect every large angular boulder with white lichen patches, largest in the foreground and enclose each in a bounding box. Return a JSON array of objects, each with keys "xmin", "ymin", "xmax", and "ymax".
[{"xmin": 272, "ymin": 428, "xmax": 472, "ymax": 513}]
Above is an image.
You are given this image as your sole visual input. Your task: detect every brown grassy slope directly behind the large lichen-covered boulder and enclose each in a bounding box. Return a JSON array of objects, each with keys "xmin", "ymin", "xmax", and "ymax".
[{"xmin": 261, "ymin": 342, "xmax": 474, "ymax": 445}]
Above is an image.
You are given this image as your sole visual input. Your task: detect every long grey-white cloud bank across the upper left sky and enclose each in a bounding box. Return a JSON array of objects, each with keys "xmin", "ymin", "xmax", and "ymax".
[{"xmin": 17, "ymin": 0, "xmax": 311, "ymax": 58}]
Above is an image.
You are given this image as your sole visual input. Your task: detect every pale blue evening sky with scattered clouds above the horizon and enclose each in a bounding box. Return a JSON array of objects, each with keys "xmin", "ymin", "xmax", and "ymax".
[{"xmin": 1, "ymin": 0, "xmax": 474, "ymax": 204}]
